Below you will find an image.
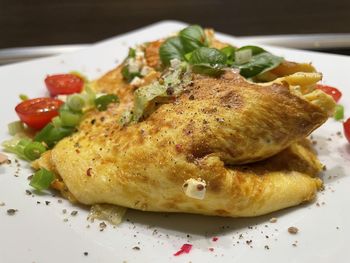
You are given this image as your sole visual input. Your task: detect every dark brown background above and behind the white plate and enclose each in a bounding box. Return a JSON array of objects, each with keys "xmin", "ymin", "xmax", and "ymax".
[{"xmin": 0, "ymin": 0, "xmax": 350, "ymax": 48}]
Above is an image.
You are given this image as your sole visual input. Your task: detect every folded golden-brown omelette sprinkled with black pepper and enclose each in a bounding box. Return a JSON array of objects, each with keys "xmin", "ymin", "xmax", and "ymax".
[{"xmin": 33, "ymin": 26, "xmax": 335, "ymax": 217}]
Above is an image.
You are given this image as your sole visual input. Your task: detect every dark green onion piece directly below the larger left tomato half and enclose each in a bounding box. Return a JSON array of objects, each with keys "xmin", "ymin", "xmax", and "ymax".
[{"xmin": 34, "ymin": 123, "xmax": 75, "ymax": 148}]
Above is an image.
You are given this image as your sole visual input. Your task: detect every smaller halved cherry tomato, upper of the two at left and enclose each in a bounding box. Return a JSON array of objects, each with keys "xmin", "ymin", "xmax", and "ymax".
[{"xmin": 45, "ymin": 74, "xmax": 84, "ymax": 97}]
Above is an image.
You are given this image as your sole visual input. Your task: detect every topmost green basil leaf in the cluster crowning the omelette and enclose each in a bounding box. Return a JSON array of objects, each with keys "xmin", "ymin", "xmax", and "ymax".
[{"xmin": 179, "ymin": 25, "xmax": 208, "ymax": 53}]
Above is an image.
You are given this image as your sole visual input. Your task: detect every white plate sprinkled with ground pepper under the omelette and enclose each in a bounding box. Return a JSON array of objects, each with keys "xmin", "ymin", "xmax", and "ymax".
[{"xmin": 0, "ymin": 21, "xmax": 350, "ymax": 263}]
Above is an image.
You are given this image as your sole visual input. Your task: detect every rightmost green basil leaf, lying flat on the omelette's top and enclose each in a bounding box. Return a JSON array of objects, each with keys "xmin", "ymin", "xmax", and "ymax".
[{"xmin": 233, "ymin": 51, "xmax": 283, "ymax": 78}]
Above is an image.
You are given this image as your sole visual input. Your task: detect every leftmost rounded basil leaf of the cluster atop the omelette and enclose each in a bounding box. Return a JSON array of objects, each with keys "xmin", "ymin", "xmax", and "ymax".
[{"xmin": 159, "ymin": 37, "xmax": 186, "ymax": 66}]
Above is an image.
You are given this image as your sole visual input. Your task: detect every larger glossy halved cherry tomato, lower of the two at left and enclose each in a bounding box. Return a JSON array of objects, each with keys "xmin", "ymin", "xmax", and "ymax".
[{"xmin": 15, "ymin": 98, "xmax": 63, "ymax": 129}]
